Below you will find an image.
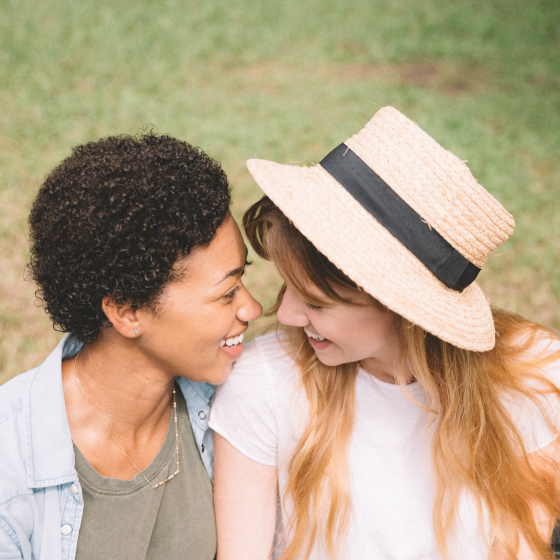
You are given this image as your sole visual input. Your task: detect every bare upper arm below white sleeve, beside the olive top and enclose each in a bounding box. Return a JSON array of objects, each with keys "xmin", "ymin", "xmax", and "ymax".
[{"xmin": 214, "ymin": 433, "xmax": 278, "ymax": 560}]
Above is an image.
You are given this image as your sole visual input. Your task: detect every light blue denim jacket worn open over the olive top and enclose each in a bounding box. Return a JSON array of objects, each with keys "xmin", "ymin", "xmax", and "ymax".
[{"xmin": 0, "ymin": 335, "xmax": 215, "ymax": 560}]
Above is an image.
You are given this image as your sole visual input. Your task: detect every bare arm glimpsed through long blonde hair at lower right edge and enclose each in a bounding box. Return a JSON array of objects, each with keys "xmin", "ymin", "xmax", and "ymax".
[{"xmin": 489, "ymin": 437, "xmax": 560, "ymax": 560}]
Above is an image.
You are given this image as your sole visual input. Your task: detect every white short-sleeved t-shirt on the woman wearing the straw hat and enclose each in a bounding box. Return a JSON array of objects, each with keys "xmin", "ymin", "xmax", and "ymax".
[{"xmin": 209, "ymin": 333, "xmax": 560, "ymax": 560}]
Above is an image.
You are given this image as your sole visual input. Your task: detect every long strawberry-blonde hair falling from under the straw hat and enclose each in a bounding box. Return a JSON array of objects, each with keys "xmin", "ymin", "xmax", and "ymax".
[{"xmin": 243, "ymin": 197, "xmax": 560, "ymax": 560}]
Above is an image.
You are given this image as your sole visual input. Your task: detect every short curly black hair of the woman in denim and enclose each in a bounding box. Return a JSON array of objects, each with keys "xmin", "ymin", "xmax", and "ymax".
[{"xmin": 28, "ymin": 132, "xmax": 231, "ymax": 342}]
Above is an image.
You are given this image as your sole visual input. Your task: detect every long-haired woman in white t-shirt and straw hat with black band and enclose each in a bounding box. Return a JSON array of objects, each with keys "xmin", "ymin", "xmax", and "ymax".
[{"xmin": 210, "ymin": 107, "xmax": 560, "ymax": 560}]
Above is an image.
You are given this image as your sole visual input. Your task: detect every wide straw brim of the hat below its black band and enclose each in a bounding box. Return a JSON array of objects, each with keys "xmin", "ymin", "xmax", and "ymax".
[{"xmin": 247, "ymin": 159, "xmax": 495, "ymax": 351}]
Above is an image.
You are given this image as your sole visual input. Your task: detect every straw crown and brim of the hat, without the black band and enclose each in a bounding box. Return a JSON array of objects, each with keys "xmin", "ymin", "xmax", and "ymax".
[{"xmin": 247, "ymin": 107, "xmax": 514, "ymax": 351}]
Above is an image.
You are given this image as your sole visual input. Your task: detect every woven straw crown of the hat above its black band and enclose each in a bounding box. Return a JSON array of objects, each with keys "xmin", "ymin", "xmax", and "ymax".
[{"xmin": 346, "ymin": 107, "xmax": 515, "ymax": 268}]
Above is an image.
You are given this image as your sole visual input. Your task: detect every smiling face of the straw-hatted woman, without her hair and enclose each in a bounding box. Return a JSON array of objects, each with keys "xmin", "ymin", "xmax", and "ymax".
[{"xmin": 277, "ymin": 282, "xmax": 399, "ymax": 382}]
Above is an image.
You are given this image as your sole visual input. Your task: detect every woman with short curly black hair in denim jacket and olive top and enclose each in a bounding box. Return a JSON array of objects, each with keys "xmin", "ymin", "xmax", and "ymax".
[{"xmin": 0, "ymin": 133, "xmax": 262, "ymax": 560}]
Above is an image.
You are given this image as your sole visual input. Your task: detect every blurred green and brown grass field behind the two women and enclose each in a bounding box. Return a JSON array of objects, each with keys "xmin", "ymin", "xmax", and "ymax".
[{"xmin": 0, "ymin": 0, "xmax": 560, "ymax": 382}]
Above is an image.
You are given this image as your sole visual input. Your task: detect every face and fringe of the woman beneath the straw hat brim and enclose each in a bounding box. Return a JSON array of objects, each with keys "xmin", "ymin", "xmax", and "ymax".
[{"xmin": 243, "ymin": 196, "xmax": 404, "ymax": 383}]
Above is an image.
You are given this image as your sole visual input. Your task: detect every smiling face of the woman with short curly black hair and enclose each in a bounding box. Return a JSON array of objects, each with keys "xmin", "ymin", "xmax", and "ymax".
[{"xmin": 136, "ymin": 217, "xmax": 262, "ymax": 384}]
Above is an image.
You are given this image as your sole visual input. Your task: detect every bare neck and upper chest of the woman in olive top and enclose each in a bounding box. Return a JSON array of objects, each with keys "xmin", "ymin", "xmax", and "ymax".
[{"xmin": 62, "ymin": 329, "xmax": 175, "ymax": 479}]
